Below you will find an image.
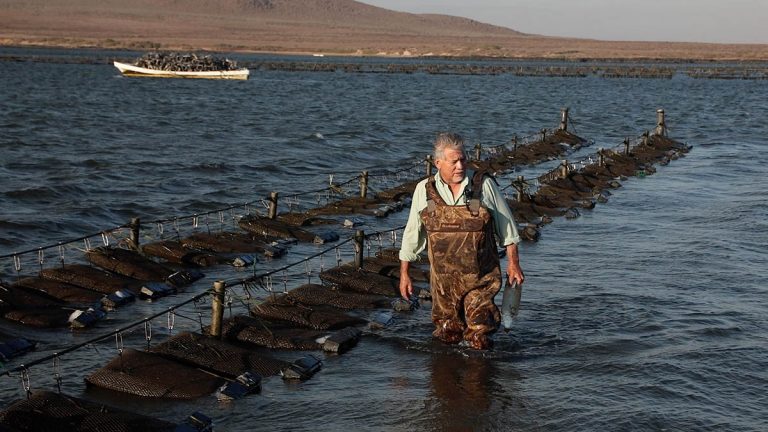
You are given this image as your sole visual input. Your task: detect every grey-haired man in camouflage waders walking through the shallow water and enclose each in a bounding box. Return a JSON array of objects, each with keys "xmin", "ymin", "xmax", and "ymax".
[{"xmin": 400, "ymin": 133, "xmax": 525, "ymax": 349}]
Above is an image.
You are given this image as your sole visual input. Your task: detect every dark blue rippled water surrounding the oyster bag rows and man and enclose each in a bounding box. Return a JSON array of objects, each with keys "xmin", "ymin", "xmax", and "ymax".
[{"xmin": 0, "ymin": 52, "xmax": 768, "ymax": 431}]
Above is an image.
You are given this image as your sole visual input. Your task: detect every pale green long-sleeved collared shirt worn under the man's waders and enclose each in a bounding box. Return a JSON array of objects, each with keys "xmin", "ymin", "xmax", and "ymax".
[{"xmin": 400, "ymin": 172, "xmax": 520, "ymax": 262}]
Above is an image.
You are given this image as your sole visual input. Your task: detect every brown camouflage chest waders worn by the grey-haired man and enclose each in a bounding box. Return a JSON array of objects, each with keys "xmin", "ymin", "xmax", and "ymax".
[{"xmin": 420, "ymin": 174, "xmax": 501, "ymax": 349}]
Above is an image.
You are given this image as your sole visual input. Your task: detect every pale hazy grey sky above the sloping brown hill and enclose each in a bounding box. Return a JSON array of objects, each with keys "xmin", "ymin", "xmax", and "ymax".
[{"xmin": 360, "ymin": 0, "xmax": 768, "ymax": 43}]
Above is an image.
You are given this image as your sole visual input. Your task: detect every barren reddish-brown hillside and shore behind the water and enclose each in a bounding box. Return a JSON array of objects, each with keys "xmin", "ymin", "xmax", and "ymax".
[{"xmin": 0, "ymin": 0, "xmax": 768, "ymax": 60}]
